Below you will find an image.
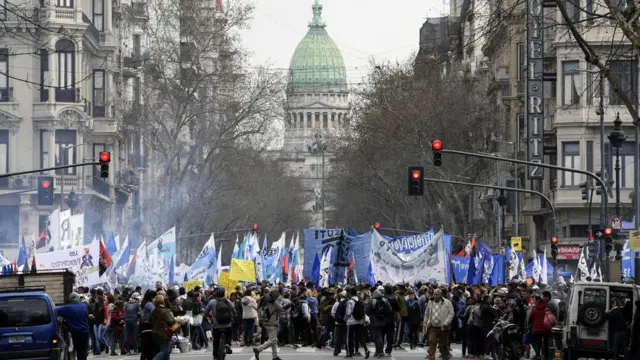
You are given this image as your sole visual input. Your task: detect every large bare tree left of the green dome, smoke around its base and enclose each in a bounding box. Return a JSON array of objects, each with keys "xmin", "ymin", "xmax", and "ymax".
[{"xmin": 132, "ymin": 0, "xmax": 296, "ymax": 246}]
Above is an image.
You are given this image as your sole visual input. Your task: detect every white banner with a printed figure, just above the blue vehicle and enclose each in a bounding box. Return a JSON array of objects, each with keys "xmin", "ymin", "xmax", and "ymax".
[{"xmin": 36, "ymin": 242, "xmax": 100, "ymax": 287}]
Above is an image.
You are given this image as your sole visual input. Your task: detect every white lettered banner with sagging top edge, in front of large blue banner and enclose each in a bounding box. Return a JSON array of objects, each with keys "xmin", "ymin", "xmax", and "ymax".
[{"xmin": 370, "ymin": 230, "xmax": 447, "ymax": 284}]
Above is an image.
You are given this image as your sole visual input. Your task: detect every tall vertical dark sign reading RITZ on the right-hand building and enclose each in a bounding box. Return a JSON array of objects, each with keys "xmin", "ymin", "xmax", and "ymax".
[{"xmin": 525, "ymin": 0, "xmax": 544, "ymax": 179}]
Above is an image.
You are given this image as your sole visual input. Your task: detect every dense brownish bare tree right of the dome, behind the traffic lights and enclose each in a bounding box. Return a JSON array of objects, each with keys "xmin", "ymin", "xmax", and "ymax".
[{"xmin": 331, "ymin": 60, "xmax": 501, "ymax": 245}]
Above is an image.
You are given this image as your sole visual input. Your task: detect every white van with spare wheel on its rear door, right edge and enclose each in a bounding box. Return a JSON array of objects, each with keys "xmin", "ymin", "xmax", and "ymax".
[{"xmin": 562, "ymin": 282, "xmax": 640, "ymax": 360}]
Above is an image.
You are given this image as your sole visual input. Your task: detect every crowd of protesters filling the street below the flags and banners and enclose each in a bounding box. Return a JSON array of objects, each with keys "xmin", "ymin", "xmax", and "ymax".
[{"xmin": 52, "ymin": 282, "xmax": 640, "ymax": 360}]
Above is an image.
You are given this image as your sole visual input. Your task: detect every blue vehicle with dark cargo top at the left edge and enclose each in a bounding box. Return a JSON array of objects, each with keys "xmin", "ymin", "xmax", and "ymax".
[{"xmin": 0, "ymin": 272, "xmax": 73, "ymax": 360}]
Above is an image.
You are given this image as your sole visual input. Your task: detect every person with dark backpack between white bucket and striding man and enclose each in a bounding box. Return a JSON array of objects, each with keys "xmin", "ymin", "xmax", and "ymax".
[{"xmin": 207, "ymin": 286, "xmax": 236, "ymax": 359}]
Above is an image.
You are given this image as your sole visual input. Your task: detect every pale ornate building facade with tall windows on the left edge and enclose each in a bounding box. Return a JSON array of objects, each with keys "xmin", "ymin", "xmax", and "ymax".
[{"xmin": 0, "ymin": 0, "xmax": 148, "ymax": 258}]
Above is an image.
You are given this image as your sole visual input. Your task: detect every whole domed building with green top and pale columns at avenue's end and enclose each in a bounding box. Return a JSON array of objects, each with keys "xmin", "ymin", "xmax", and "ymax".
[{"xmin": 282, "ymin": 0, "xmax": 350, "ymax": 227}]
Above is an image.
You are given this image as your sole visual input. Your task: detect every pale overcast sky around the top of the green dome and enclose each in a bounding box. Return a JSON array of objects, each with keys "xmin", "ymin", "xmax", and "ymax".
[{"xmin": 244, "ymin": 0, "xmax": 448, "ymax": 84}]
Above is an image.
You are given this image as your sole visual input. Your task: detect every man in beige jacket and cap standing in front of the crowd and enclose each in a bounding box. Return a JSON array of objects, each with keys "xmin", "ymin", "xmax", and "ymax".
[{"xmin": 424, "ymin": 289, "xmax": 455, "ymax": 360}]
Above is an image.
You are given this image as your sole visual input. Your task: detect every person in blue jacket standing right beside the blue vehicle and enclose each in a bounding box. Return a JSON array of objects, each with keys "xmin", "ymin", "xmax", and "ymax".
[{"xmin": 56, "ymin": 292, "xmax": 89, "ymax": 360}]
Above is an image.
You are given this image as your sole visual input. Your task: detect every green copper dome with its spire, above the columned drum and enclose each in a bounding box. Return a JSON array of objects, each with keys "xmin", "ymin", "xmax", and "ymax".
[{"xmin": 288, "ymin": 0, "xmax": 347, "ymax": 93}]
